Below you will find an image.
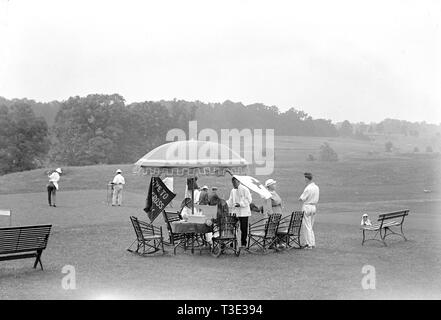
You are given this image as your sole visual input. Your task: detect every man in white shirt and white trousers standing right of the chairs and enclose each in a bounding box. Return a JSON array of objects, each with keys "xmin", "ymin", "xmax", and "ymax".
[{"xmin": 299, "ymin": 172, "xmax": 320, "ymax": 249}]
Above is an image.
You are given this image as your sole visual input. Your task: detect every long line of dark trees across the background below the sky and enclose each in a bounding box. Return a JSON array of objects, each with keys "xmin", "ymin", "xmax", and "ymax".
[{"xmin": 0, "ymin": 94, "xmax": 438, "ymax": 174}]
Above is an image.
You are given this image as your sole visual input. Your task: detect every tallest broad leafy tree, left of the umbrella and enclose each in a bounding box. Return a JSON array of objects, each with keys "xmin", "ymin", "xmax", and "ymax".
[{"xmin": 51, "ymin": 94, "xmax": 128, "ymax": 165}]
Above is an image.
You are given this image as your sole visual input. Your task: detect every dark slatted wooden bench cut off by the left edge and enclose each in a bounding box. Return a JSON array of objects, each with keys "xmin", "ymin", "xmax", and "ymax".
[{"xmin": 0, "ymin": 225, "xmax": 52, "ymax": 270}]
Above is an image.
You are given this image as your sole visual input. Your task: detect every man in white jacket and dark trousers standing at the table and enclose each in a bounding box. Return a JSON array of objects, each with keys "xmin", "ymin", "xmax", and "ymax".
[{"xmin": 227, "ymin": 178, "xmax": 252, "ymax": 247}]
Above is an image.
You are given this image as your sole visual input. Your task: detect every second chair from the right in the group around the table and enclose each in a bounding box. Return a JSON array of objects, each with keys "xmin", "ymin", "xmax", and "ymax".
[{"xmin": 247, "ymin": 213, "xmax": 282, "ymax": 253}]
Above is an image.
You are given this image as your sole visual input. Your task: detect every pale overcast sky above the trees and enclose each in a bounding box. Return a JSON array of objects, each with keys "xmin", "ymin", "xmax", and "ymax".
[{"xmin": 0, "ymin": 0, "xmax": 441, "ymax": 123}]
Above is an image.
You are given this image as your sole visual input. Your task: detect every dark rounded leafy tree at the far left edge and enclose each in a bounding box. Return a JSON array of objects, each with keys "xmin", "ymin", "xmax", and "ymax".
[{"xmin": 0, "ymin": 101, "xmax": 49, "ymax": 174}]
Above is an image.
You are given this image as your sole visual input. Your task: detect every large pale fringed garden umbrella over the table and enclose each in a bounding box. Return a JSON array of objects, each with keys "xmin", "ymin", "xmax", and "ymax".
[{"xmin": 134, "ymin": 140, "xmax": 248, "ymax": 215}]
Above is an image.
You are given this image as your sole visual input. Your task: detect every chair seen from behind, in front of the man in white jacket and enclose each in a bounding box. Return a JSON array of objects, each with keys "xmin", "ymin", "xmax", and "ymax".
[{"xmin": 211, "ymin": 216, "xmax": 240, "ymax": 258}]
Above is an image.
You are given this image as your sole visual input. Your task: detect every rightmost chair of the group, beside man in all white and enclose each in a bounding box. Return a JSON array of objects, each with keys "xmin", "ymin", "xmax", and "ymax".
[{"xmin": 277, "ymin": 211, "xmax": 303, "ymax": 249}]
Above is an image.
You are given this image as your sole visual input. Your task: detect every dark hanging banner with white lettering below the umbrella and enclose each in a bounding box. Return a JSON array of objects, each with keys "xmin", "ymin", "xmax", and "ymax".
[{"xmin": 144, "ymin": 177, "xmax": 176, "ymax": 222}]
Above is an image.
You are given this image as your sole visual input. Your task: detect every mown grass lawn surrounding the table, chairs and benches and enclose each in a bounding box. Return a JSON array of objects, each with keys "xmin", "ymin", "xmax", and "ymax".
[{"xmin": 0, "ymin": 138, "xmax": 441, "ymax": 299}]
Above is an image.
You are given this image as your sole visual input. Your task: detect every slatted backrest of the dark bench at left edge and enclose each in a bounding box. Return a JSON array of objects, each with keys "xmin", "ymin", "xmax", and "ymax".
[{"xmin": 0, "ymin": 225, "xmax": 52, "ymax": 254}]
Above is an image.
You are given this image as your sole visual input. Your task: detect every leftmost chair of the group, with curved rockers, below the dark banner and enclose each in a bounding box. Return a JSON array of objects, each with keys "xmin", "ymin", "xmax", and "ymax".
[{"xmin": 127, "ymin": 216, "xmax": 165, "ymax": 255}]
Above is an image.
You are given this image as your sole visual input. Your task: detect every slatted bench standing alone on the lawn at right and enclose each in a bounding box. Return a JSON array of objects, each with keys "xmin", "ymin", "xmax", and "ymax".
[{"xmin": 361, "ymin": 210, "xmax": 409, "ymax": 246}]
